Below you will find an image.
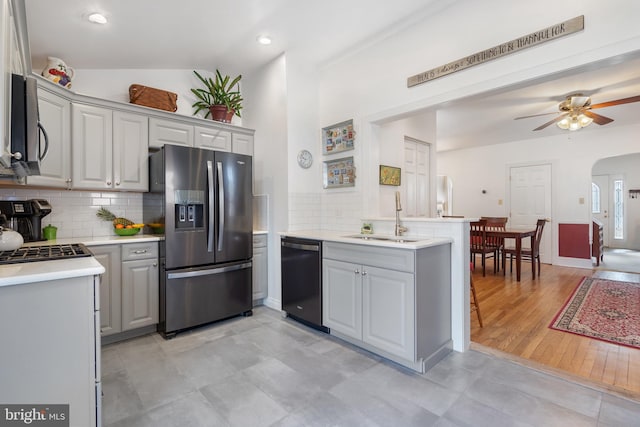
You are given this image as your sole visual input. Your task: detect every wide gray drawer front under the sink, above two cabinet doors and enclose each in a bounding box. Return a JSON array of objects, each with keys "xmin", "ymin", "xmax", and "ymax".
[{"xmin": 322, "ymin": 242, "xmax": 415, "ymax": 273}]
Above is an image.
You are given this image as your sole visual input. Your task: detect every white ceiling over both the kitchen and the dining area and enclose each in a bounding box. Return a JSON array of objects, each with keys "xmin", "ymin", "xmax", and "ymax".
[{"xmin": 25, "ymin": 0, "xmax": 640, "ymax": 150}]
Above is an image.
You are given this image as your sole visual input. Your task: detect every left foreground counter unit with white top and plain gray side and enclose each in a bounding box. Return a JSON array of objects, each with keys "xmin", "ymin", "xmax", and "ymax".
[{"xmin": 0, "ymin": 256, "xmax": 104, "ymax": 426}]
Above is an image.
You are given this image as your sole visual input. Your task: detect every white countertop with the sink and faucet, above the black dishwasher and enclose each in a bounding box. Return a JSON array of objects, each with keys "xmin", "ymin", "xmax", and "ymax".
[{"xmin": 278, "ymin": 230, "xmax": 453, "ymax": 250}]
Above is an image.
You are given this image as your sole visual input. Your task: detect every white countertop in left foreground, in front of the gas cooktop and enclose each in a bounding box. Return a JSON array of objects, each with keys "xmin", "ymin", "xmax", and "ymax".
[{"xmin": 0, "ymin": 257, "xmax": 104, "ymax": 286}]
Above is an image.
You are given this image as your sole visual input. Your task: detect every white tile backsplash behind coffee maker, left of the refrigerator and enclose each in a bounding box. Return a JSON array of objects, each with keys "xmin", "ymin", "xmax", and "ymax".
[{"xmin": 0, "ymin": 188, "xmax": 142, "ymax": 238}]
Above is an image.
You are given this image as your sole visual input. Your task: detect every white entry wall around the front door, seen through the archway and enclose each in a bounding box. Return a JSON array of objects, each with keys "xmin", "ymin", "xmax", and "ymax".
[{"xmin": 591, "ymin": 153, "xmax": 640, "ymax": 250}]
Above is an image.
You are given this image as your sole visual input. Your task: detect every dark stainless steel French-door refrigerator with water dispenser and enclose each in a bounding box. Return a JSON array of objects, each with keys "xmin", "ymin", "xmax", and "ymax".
[{"xmin": 143, "ymin": 145, "xmax": 253, "ymax": 337}]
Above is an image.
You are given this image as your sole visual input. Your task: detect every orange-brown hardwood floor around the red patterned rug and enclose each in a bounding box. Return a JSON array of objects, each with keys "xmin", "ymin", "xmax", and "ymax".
[{"xmin": 471, "ymin": 261, "xmax": 640, "ymax": 400}]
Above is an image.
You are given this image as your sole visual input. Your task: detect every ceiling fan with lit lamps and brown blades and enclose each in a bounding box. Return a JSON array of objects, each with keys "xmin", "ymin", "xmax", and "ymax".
[{"xmin": 514, "ymin": 93, "xmax": 640, "ymax": 131}]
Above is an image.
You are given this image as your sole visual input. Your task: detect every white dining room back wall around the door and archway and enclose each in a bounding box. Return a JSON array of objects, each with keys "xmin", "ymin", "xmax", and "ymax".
[{"xmin": 438, "ymin": 125, "xmax": 640, "ymax": 268}]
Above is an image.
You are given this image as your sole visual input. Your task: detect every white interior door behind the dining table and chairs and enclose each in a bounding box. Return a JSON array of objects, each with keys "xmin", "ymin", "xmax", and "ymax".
[{"xmin": 507, "ymin": 164, "xmax": 553, "ymax": 264}]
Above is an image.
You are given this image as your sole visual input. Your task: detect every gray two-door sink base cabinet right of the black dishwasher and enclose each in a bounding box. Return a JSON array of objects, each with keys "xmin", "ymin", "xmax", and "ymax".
[{"xmin": 322, "ymin": 242, "xmax": 451, "ymax": 372}]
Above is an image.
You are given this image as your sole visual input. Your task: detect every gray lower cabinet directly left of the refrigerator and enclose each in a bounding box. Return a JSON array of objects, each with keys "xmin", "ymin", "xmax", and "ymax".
[{"xmin": 89, "ymin": 242, "xmax": 160, "ymax": 342}]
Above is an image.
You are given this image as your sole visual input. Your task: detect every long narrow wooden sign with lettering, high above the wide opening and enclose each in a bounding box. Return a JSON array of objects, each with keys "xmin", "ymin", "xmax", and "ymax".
[{"xmin": 407, "ymin": 15, "xmax": 584, "ymax": 87}]
